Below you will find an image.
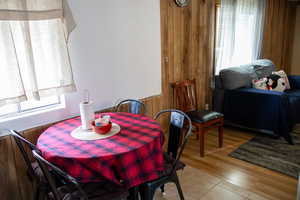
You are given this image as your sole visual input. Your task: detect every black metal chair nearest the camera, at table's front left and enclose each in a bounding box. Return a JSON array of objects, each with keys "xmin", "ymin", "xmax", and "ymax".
[{"xmin": 32, "ymin": 150, "xmax": 128, "ymax": 200}]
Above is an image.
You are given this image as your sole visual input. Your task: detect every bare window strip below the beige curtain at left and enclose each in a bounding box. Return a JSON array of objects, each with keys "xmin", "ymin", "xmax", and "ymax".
[{"xmin": 0, "ymin": 96, "xmax": 61, "ymax": 119}]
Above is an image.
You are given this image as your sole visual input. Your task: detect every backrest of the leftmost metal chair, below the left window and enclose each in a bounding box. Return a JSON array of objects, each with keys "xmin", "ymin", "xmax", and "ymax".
[{"xmin": 10, "ymin": 130, "xmax": 37, "ymax": 180}]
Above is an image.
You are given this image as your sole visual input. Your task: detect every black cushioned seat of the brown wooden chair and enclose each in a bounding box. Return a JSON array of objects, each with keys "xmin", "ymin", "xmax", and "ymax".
[{"xmin": 186, "ymin": 110, "xmax": 224, "ymax": 123}]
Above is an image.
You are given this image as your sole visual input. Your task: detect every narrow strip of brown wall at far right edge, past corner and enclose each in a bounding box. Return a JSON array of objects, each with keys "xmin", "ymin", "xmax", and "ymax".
[{"xmin": 291, "ymin": 6, "xmax": 300, "ymax": 75}]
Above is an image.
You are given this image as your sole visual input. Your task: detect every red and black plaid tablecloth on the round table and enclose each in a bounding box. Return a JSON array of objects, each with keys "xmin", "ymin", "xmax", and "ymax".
[{"xmin": 37, "ymin": 113, "xmax": 164, "ymax": 188}]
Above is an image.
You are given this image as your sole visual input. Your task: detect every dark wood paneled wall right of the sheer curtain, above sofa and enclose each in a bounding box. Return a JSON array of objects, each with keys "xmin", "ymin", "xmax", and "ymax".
[{"xmin": 262, "ymin": 0, "xmax": 296, "ymax": 74}]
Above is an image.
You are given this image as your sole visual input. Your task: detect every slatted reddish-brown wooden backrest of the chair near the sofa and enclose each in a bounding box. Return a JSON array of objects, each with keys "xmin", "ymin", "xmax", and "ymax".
[{"xmin": 171, "ymin": 79, "xmax": 197, "ymax": 112}]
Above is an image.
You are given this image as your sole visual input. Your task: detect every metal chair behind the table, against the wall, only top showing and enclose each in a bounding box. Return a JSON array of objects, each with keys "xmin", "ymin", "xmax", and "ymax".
[{"xmin": 115, "ymin": 99, "xmax": 147, "ymax": 114}]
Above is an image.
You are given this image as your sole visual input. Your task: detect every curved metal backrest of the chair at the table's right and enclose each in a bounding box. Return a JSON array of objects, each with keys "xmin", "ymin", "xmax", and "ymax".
[{"xmin": 154, "ymin": 109, "xmax": 192, "ymax": 174}]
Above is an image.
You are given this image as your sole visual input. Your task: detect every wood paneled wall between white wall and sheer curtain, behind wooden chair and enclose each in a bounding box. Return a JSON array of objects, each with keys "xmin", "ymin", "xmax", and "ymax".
[{"xmin": 161, "ymin": 0, "xmax": 215, "ymax": 108}]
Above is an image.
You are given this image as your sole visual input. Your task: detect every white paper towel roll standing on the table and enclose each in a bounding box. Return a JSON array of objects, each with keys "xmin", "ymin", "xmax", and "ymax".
[{"xmin": 79, "ymin": 102, "xmax": 95, "ymax": 130}]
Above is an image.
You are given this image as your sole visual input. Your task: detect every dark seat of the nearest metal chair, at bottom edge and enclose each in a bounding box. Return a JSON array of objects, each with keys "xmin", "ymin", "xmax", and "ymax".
[{"xmin": 49, "ymin": 182, "xmax": 129, "ymax": 200}]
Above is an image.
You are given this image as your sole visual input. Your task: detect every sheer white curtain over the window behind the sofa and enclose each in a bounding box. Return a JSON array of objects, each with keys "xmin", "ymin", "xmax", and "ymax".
[{"xmin": 215, "ymin": 0, "xmax": 266, "ymax": 74}]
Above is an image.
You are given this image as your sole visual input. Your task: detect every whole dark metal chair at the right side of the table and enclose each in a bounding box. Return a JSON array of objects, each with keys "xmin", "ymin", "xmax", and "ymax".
[{"xmin": 140, "ymin": 109, "xmax": 192, "ymax": 200}]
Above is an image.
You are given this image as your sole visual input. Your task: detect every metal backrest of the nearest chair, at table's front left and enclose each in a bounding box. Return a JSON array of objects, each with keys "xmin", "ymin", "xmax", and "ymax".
[{"xmin": 32, "ymin": 150, "xmax": 88, "ymax": 200}]
